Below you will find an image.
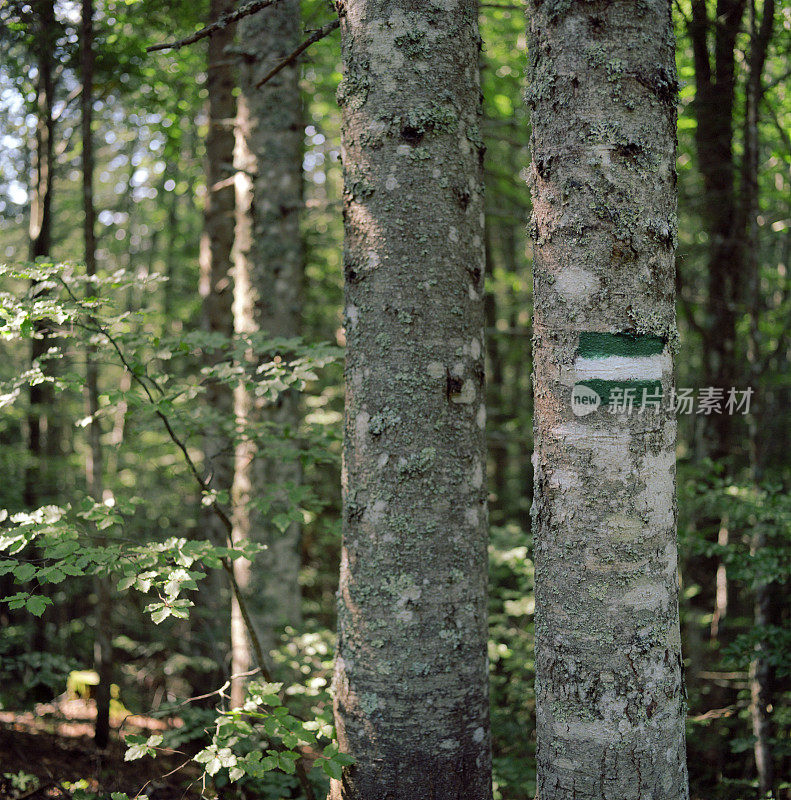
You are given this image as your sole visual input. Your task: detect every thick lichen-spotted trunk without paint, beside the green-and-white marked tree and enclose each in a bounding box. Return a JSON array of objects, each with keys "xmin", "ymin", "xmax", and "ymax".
[{"xmin": 330, "ymin": 0, "xmax": 491, "ymax": 800}]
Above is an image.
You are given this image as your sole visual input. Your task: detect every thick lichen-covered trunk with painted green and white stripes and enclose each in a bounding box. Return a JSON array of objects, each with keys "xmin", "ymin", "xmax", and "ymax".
[{"xmin": 528, "ymin": 0, "xmax": 688, "ymax": 800}]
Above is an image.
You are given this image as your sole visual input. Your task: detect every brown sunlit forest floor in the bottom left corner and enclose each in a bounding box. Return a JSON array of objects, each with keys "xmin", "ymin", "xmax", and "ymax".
[{"xmin": 0, "ymin": 700, "xmax": 201, "ymax": 800}]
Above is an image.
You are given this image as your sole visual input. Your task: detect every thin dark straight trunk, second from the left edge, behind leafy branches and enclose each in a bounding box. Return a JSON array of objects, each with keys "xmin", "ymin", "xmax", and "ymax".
[{"xmin": 80, "ymin": 0, "xmax": 113, "ymax": 748}]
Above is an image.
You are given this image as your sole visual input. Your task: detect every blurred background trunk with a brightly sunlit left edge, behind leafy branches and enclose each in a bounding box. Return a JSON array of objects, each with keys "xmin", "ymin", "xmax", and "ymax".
[{"xmin": 231, "ymin": 0, "xmax": 304, "ymax": 704}]
